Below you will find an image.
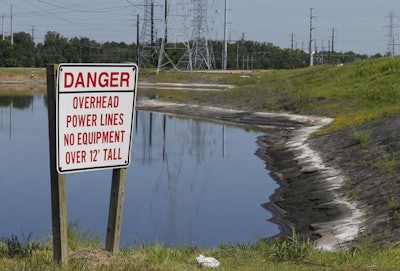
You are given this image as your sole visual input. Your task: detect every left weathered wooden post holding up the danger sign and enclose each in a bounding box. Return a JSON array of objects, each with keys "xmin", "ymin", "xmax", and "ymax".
[{"xmin": 46, "ymin": 65, "xmax": 68, "ymax": 264}]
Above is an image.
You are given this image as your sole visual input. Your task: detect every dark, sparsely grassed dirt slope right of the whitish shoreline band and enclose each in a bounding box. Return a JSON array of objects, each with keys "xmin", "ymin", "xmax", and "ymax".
[{"xmin": 309, "ymin": 117, "xmax": 400, "ymax": 246}]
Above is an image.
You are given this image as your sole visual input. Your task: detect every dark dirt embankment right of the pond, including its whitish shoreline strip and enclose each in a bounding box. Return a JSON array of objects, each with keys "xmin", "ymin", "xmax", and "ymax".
[{"xmin": 138, "ymin": 92, "xmax": 400, "ymax": 249}]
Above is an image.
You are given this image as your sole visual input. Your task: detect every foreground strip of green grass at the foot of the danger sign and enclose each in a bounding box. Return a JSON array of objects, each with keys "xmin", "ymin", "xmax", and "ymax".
[{"xmin": 0, "ymin": 234, "xmax": 400, "ymax": 271}]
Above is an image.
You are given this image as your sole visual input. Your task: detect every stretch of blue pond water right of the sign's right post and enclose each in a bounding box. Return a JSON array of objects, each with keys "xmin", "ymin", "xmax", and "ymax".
[{"xmin": 126, "ymin": 112, "xmax": 278, "ymax": 249}]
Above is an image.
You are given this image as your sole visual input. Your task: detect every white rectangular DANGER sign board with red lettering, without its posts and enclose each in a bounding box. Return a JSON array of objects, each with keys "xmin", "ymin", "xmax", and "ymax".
[{"xmin": 56, "ymin": 64, "xmax": 138, "ymax": 174}]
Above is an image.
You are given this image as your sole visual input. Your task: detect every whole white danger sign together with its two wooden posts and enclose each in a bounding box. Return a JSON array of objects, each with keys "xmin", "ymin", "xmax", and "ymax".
[{"xmin": 47, "ymin": 64, "xmax": 138, "ymax": 264}]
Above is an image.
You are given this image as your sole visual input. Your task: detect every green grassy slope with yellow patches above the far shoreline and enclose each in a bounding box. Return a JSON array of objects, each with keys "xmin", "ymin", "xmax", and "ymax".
[{"xmin": 145, "ymin": 57, "xmax": 400, "ymax": 133}]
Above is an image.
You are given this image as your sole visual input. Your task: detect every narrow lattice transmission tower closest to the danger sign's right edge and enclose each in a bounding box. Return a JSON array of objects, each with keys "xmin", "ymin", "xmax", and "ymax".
[{"xmin": 138, "ymin": 0, "xmax": 159, "ymax": 67}]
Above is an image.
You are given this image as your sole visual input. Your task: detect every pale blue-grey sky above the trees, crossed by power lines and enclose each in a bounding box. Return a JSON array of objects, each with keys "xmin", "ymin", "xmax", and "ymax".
[{"xmin": 0, "ymin": 0, "xmax": 400, "ymax": 55}]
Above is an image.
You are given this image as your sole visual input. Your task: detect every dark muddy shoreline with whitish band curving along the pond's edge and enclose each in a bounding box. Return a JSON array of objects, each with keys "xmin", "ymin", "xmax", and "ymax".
[{"xmin": 137, "ymin": 100, "xmax": 363, "ymax": 250}]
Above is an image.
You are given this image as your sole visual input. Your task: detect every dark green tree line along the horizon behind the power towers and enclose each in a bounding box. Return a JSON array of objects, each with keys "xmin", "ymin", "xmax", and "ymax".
[{"xmin": 0, "ymin": 31, "xmax": 381, "ymax": 70}]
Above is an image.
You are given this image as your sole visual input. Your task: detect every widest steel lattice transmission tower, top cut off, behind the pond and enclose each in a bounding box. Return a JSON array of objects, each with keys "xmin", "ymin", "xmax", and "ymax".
[{"xmin": 191, "ymin": 0, "xmax": 214, "ymax": 70}]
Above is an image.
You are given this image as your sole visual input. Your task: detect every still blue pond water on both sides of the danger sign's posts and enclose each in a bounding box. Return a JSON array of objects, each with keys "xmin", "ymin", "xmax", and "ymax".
[{"xmin": 0, "ymin": 95, "xmax": 279, "ymax": 247}]
